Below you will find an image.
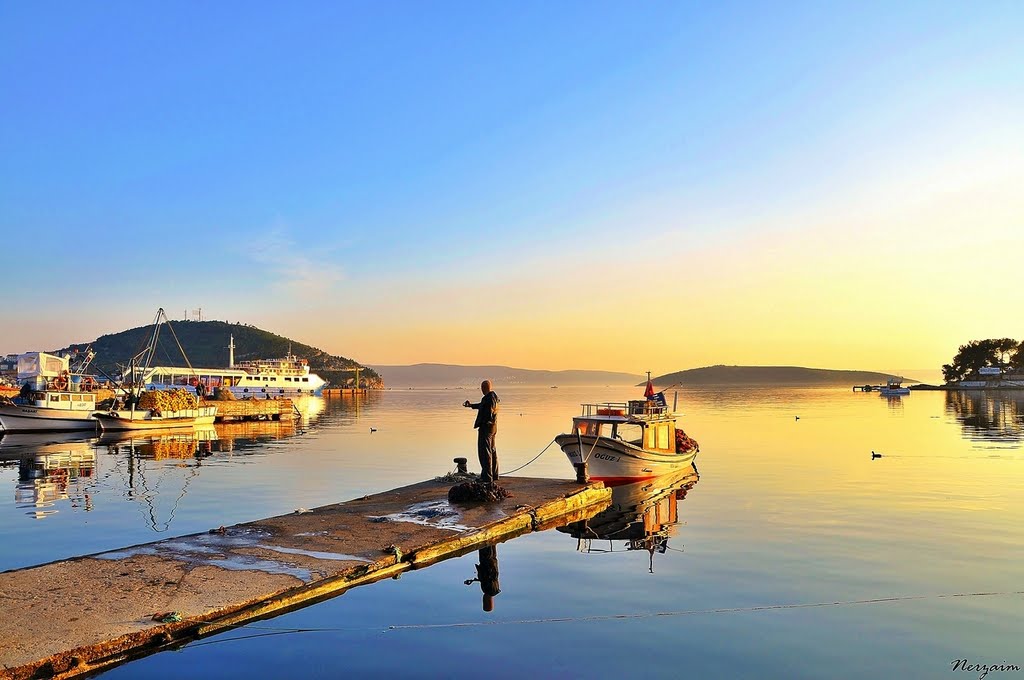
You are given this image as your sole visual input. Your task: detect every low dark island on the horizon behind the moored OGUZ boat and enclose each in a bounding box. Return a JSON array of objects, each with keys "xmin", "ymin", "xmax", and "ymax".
[{"xmin": 641, "ymin": 365, "xmax": 921, "ymax": 387}]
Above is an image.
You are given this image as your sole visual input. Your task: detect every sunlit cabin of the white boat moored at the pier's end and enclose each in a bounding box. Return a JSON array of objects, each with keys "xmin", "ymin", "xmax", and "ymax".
[{"xmin": 572, "ymin": 399, "xmax": 676, "ymax": 453}]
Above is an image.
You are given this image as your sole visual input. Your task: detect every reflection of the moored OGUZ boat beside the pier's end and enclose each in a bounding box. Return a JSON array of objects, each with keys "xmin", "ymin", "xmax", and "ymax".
[{"xmin": 558, "ymin": 464, "xmax": 699, "ymax": 573}]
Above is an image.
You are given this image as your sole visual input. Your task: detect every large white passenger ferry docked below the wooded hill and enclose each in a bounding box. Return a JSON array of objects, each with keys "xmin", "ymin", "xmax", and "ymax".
[{"xmin": 142, "ymin": 336, "xmax": 327, "ymax": 398}]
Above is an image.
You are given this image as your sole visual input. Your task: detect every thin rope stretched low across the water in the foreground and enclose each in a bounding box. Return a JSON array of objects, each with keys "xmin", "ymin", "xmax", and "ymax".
[{"xmin": 189, "ymin": 590, "xmax": 1024, "ymax": 647}]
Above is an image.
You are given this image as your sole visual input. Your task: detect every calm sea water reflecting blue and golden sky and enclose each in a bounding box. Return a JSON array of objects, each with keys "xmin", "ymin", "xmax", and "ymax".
[{"xmin": 0, "ymin": 386, "xmax": 1024, "ymax": 679}]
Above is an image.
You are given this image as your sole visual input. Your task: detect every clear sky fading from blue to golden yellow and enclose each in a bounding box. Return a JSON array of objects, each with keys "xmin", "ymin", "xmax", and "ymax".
[{"xmin": 0, "ymin": 1, "xmax": 1024, "ymax": 375}]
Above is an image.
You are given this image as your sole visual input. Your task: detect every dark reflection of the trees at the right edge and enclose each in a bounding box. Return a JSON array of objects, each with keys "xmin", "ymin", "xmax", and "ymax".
[{"xmin": 945, "ymin": 390, "xmax": 1024, "ymax": 442}]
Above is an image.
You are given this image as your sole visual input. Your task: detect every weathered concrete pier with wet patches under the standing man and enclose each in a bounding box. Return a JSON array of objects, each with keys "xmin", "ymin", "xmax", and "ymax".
[{"xmin": 0, "ymin": 477, "xmax": 611, "ymax": 680}]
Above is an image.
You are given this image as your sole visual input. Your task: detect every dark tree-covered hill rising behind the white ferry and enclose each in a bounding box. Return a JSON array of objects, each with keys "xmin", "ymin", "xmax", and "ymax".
[{"xmin": 56, "ymin": 321, "xmax": 383, "ymax": 387}]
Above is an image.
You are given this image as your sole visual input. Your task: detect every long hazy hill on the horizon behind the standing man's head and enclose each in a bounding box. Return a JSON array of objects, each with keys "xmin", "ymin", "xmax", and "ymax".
[{"xmin": 373, "ymin": 364, "xmax": 641, "ymax": 387}]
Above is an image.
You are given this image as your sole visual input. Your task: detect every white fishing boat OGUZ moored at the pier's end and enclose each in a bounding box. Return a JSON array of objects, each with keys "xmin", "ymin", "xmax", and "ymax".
[{"xmin": 555, "ymin": 381, "xmax": 699, "ymax": 484}]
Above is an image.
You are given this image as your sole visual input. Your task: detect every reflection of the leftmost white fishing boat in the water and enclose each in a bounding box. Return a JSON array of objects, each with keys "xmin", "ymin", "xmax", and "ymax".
[{"xmin": 0, "ymin": 431, "xmax": 96, "ymax": 519}]
